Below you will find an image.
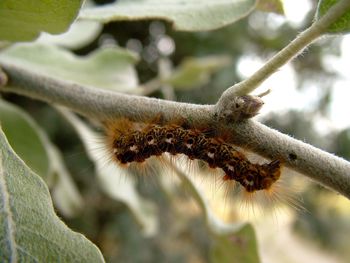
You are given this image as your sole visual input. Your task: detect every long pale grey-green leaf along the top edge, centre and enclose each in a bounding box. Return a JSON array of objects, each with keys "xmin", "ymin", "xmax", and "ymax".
[{"xmin": 80, "ymin": 0, "xmax": 256, "ymax": 31}]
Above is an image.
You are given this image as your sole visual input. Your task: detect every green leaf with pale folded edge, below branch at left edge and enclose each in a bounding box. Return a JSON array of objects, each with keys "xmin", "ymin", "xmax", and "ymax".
[{"xmin": 0, "ymin": 99, "xmax": 83, "ymax": 217}]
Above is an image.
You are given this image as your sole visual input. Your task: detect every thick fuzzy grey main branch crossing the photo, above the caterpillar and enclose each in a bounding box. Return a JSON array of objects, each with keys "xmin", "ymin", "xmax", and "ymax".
[{"xmin": 0, "ymin": 63, "xmax": 350, "ymax": 199}]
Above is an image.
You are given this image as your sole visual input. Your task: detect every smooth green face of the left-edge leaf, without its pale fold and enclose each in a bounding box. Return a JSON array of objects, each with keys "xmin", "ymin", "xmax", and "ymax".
[{"xmin": 0, "ymin": 99, "xmax": 52, "ymax": 181}]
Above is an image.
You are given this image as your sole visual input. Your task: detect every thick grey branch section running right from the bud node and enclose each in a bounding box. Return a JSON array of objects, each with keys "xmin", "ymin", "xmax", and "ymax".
[{"xmin": 231, "ymin": 121, "xmax": 350, "ymax": 199}]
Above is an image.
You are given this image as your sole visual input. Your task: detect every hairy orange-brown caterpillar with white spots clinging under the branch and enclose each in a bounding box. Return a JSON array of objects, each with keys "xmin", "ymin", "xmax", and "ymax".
[{"xmin": 105, "ymin": 118, "xmax": 281, "ymax": 193}]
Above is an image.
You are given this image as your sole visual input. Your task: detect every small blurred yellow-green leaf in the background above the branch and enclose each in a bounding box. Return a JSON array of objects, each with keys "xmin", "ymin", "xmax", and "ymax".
[{"xmin": 162, "ymin": 56, "xmax": 231, "ymax": 89}]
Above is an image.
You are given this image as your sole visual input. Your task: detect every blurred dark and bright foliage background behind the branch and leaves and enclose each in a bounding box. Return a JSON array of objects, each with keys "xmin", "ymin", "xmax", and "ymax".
[{"xmin": 3, "ymin": 0, "xmax": 350, "ymax": 262}]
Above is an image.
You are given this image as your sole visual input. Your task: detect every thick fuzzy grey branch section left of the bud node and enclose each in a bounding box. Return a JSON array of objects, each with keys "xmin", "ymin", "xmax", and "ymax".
[{"xmin": 0, "ymin": 62, "xmax": 213, "ymax": 126}]
